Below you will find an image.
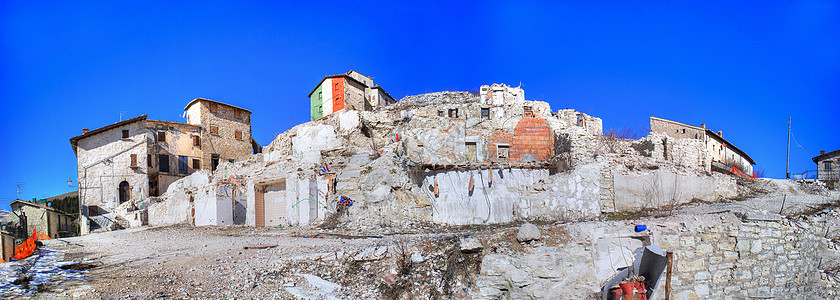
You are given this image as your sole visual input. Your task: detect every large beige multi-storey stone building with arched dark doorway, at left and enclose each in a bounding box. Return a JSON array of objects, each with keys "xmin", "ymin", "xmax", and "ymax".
[{"xmin": 70, "ymin": 98, "xmax": 260, "ymax": 234}]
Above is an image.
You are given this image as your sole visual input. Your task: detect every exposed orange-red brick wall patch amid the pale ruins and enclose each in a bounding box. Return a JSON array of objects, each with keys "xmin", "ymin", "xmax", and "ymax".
[{"xmin": 510, "ymin": 118, "xmax": 554, "ymax": 161}]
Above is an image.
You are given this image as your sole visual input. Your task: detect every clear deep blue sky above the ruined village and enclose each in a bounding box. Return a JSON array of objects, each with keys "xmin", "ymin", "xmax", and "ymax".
[{"xmin": 0, "ymin": 0, "xmax": 840, "ymax": 208}]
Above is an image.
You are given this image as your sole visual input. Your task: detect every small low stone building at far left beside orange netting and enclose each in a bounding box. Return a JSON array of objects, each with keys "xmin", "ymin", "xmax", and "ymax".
[{"xmin": 9, "ymin": 200, "xmax": 75, "ymax": 238}]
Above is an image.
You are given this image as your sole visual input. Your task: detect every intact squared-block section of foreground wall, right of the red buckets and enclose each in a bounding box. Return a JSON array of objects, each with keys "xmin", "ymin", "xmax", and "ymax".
[{"xmin": 659, "ymin": 218, "xmax": 827, "ymax": 299}]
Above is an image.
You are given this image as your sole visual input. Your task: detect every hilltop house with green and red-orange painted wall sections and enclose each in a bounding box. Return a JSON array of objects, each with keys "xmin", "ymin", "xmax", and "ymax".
[{"xmin": 307, "ymin": 70, "xmax": 396, "ymax": 121}]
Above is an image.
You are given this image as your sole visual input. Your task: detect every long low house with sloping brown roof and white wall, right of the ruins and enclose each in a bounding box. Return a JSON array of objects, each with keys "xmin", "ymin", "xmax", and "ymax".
[{"xmin": 650, "ymin": 117, "xmax": 755, "ymax": 176}]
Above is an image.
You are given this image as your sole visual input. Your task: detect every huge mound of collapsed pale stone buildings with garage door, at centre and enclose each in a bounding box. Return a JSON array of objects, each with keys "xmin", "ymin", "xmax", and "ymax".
[{"xmin": 131, "ymin": 79, "xmax": 752, "ymax": 228}]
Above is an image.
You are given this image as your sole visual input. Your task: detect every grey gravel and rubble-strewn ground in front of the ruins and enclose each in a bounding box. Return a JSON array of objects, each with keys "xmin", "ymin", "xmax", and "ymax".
[{"xmin": 0, "ymin": 180, "xmax": 840, "ymax": 299}]
